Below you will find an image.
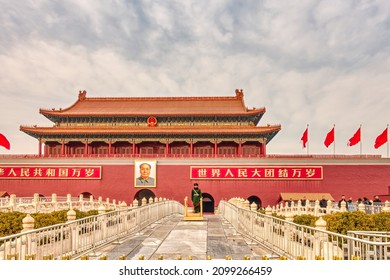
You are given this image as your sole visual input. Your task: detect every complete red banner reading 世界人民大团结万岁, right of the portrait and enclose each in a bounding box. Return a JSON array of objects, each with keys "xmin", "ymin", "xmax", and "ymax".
[{"xmin": 191, "ymin": 166, "xmax": 323, "ymax": 180}]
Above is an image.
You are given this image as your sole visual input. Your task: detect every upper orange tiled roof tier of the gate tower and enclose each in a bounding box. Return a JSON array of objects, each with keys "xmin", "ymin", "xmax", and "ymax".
[{"xmin": 39, "ymin": 90, "xmax": 265, "ymax": 119}]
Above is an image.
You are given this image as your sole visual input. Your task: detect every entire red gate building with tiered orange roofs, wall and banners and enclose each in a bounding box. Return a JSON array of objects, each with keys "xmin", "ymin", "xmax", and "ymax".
[{"xmin": 0, "ymin": 90, "xmax": 390, "ymax": 212}]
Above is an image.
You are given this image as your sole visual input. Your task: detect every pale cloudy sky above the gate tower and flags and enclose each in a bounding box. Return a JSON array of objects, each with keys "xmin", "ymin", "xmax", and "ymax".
[{"xmin": 0, "ymin": 0, "xmax": 390, "ymax": 156}]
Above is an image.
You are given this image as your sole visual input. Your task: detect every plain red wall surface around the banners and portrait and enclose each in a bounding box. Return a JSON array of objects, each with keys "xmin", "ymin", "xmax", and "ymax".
[{"xmin": 0, "ymin": 162, "xmax": 390, "ymax": 207}]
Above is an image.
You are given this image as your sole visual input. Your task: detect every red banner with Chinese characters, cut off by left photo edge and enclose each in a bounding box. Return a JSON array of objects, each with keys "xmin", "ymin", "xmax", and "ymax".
[{"xmin": 0, "ymin": 165, "xmax": 102, "ymax": 180}]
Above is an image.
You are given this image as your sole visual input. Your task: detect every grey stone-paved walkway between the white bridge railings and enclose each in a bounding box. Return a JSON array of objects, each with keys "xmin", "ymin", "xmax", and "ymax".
[{"xmin": 90, "ymin": 214, "xmax": 270, "ymax": 260}]
